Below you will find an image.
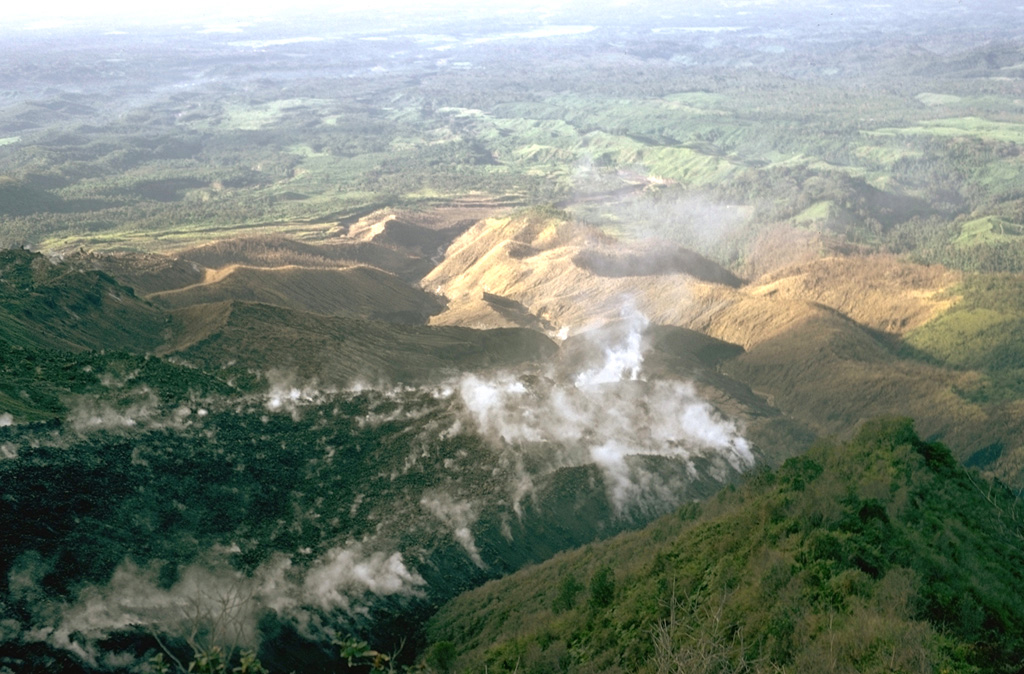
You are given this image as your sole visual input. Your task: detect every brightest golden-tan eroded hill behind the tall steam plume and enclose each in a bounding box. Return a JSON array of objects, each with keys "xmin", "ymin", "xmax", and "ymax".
[{"xmin": 421, "ymin": 212, "xmax": 737, "ymax": 331}]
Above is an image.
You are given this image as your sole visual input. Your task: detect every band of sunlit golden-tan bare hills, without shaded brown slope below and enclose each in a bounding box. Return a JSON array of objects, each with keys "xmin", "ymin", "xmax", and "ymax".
[{"xmin": 422, "ymin": 218, "xmax": 961, "ymax": 348}]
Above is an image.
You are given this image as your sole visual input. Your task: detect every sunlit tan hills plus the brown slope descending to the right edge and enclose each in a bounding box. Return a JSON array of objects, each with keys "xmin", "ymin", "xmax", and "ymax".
[{"xmin": 423, "ymin": 214, "xmax": 1024, "ymax": 481}]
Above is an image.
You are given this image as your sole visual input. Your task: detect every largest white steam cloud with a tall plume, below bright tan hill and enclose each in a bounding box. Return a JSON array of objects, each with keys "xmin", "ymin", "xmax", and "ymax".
[{"xmin": 457, "ymin": 314, "xmax": 755, "ymax": 512}]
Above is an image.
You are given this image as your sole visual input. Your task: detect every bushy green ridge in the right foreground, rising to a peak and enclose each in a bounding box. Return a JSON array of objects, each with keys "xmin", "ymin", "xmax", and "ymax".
[{"xmin": 427, "ymin": 420, "xmax": 1024, "ymax": 672}]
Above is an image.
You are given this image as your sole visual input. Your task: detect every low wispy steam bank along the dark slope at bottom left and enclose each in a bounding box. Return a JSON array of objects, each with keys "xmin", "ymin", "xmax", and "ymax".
[{"xmin": 8, "ymin": 542, "xmax": 425, "ymax": 667}]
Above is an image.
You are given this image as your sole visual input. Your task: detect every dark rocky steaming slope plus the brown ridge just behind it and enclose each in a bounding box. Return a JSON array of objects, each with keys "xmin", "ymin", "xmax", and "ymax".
[{"xmin": 0, "ymin": 315, "xmax": 774, "ymax": 672}]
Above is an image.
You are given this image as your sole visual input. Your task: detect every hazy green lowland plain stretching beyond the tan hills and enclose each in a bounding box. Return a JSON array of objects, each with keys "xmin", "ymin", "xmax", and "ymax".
[{"xmin": 6, "ymin": 6, "xmax": 1024, "ymax": 270}]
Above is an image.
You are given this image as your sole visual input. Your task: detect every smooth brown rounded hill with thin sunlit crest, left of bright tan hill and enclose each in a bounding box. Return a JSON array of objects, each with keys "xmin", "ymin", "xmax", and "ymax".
[{"xmin": 148, "ymin": 265, "xmax": 441, "ymax": 323}]
